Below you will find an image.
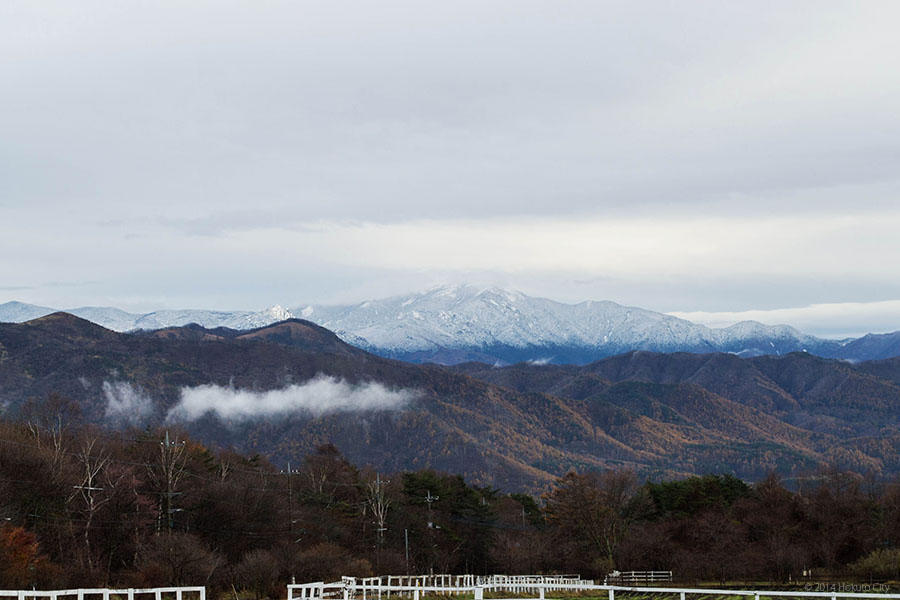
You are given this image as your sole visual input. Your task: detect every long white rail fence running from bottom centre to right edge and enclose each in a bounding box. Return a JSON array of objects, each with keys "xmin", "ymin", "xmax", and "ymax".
[{"xmin": 287, "ymin": 575, "xmax": 900, "ymax": 600}]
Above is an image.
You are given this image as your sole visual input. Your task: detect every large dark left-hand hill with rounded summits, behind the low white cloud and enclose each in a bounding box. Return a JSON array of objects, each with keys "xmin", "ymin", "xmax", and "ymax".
[{"xmin": 0, "ymin": 315, "xmax": 624, "ymax": 489}]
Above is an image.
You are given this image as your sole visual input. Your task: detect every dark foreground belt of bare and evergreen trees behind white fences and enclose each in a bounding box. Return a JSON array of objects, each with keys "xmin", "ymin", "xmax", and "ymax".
[{"xmin": 0, "ymin": 407, "xmax": 900, "ymax": 598}]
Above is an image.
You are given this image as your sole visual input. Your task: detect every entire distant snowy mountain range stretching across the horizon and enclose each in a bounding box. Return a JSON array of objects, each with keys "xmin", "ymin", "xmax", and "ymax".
[{"xmin": 0, "ymin": 285, "xmax": 900, "ymax": 365}]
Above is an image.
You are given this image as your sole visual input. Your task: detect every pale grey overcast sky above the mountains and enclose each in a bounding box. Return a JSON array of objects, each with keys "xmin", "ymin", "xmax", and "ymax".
[{"xmin": 0, "ymin": 0, "xmax": 900, "ymax": 335}]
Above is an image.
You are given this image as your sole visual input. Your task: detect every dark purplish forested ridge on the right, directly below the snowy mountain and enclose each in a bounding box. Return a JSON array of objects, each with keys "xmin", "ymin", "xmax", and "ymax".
[{"xmin": 455, "ymin": 352, "xmax": 900, "ymax": 442}]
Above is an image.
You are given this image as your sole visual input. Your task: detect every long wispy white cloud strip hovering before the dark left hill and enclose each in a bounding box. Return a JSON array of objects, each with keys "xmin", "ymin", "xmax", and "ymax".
[{"xmin": 168, "ymin": 375, "xmax": 417, "ymax": 421}]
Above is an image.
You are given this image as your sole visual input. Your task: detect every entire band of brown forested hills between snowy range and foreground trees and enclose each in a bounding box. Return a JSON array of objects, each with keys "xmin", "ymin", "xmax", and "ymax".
[{"xmin": 0, "ymin": 313, "xmax": 900, "ymax": 490}]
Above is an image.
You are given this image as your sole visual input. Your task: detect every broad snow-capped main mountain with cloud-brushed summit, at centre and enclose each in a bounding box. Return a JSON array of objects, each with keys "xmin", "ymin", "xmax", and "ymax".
[{"xmin": 292, "ymin": 285, "xmax": 837, "ymax": 362}]
